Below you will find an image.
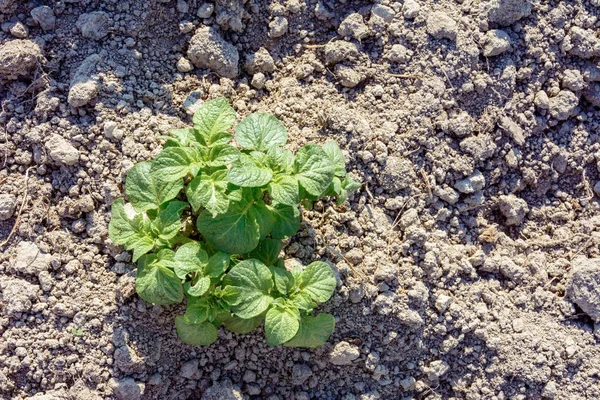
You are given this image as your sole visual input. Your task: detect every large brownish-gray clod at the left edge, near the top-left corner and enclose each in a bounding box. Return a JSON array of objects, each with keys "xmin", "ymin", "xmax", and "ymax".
[{"xmin": 0, "ymin": 39, "xmax": 43, "ymax": 80}]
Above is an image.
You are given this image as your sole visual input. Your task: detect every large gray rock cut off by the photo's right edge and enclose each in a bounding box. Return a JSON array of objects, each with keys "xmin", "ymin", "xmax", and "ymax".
[{"xmin": 566, "ymin": 257, "xmax": 600, "ymax": 322}]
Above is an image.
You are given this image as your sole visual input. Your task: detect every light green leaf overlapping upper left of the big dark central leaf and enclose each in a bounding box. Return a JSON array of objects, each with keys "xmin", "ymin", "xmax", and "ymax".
[{"xmin": 185, "ymin": 170, "xmax": 229, "ymax": 217}]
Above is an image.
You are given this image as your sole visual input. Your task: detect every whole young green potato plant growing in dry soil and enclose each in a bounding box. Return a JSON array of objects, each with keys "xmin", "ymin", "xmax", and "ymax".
[{"xmin": 109, "ymin": 98, "xmax": 359, "ymax": 347}]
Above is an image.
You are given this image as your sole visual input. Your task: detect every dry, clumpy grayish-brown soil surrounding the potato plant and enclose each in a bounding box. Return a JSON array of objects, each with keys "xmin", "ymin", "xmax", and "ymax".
[{"xmin": 0, "ymin": 0, "xmax": 600, "ymax": 400}]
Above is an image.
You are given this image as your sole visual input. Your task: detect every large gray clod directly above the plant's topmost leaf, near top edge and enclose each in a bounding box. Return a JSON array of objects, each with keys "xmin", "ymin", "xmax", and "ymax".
[{"xmin": 187, "ymin": 26, "xmax": 239, "ymax": 78}]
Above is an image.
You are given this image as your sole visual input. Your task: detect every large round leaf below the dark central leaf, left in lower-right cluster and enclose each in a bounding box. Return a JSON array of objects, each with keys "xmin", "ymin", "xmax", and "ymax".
[{"xmin": 224, "ymin": 259, "xmax": 273, "ymax": 319}]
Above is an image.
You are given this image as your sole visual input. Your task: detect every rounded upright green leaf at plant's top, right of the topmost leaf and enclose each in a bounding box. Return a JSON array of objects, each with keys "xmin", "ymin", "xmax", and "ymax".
[{"xmin": 235, "ymin": 113, "xmax": 287, "ymax": 151}]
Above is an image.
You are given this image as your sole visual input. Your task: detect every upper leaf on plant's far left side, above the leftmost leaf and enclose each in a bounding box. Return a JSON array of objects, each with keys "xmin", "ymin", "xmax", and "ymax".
[{"xmin": 125, "ymin": 162, "xmax": 183, "ymax": 212}]
